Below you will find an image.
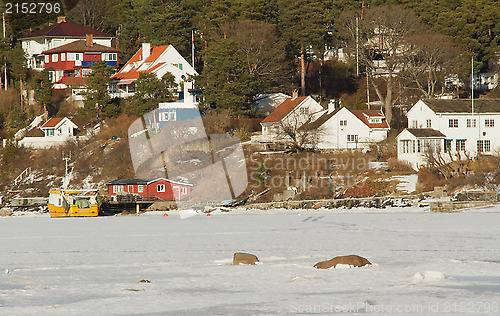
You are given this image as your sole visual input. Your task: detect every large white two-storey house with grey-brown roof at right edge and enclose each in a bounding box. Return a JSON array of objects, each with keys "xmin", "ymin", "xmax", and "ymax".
[{"xmin": 398, "ymin": 99, "xmax": 500, "ymax": 169}]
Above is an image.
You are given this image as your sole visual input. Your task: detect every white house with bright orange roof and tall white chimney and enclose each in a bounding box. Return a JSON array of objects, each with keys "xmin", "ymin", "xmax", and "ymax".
[{"xmin": 109, "ymin": 43, "xmax": 198, "ymax": 98}]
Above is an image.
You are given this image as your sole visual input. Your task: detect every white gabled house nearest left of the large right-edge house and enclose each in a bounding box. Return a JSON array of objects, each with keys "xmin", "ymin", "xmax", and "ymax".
[{"xmin": 312, "ymin": 106, "xmax": 390, "ymax": 149}]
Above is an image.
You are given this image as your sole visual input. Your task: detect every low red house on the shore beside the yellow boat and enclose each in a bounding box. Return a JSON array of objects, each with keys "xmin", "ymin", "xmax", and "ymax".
[{"xmin": 107, "ymin": 178, "xmax": 193, "ymax": 201}]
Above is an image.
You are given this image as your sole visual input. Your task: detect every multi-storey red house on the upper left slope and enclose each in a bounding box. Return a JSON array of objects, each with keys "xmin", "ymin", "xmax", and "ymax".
[{"xmin": 42, "ymin": 34, "xmax": 120, "ymax": 89}]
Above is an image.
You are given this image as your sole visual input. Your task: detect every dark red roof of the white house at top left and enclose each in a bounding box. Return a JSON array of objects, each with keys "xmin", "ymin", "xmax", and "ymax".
[{"xmin": 20, "ymin": 21, "xmax": 114, "ymax": 38}]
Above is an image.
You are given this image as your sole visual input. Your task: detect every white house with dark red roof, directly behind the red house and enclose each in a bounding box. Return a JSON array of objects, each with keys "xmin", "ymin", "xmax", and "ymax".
[{"xmin": 19, "ymin": 17, "xmax": 115, "ymax": 71}]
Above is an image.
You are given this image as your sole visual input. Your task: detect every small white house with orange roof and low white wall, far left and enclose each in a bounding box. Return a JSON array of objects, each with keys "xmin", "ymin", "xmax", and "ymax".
[{"xmin": 19, "ymin": 117, "xmax": 78, "ymax": 149}]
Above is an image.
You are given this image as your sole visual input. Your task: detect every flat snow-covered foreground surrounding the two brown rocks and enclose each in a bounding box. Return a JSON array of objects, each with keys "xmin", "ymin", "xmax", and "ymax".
[{"xmin": 0, "ymin": 207, "xmax": 500, "ymax": 315}]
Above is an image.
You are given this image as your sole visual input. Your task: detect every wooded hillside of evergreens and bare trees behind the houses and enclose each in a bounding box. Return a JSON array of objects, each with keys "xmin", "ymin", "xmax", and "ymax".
[{"xmin": 0, "ymin": 0, "xmax": 500, "ymax": 194}]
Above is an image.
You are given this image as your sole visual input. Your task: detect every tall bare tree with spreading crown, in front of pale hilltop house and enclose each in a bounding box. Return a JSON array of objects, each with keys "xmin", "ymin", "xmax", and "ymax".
[{"xmin": 338, "ymin": 6, "xmax": 423, "ymax": 122}]
